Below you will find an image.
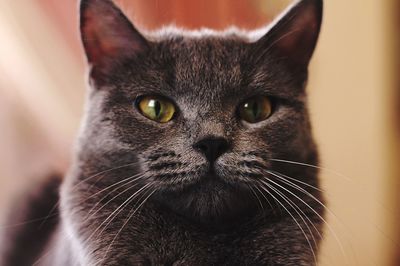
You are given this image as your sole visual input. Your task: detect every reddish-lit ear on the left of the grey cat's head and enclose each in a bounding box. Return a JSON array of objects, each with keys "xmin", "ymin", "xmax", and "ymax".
[{"xmin": 80, "ymin": 0, "xmax": 148, "ymax": 80}]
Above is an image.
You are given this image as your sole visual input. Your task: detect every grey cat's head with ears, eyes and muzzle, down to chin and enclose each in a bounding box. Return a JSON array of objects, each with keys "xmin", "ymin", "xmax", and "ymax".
[{"xmin": 64, "ymin": 0, "xmax": 322, "ymax": 224}]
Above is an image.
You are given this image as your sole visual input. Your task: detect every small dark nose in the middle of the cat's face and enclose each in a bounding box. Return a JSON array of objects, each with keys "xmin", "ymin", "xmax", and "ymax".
[{"xmin": 193, "ymin": 137, "xmax": 230, "ymax": 162}]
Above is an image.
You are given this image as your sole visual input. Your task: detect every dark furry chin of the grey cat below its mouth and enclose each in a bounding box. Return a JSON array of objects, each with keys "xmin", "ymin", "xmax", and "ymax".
[{"xmin": 155, "ymin": 177, "xmax": 259, "ymax": 226}]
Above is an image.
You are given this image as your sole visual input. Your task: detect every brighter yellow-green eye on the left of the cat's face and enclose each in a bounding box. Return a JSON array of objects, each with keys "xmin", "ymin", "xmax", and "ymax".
[{"xmin": 136, "ymin": 96, "xmax": 176, "ymax": 123}]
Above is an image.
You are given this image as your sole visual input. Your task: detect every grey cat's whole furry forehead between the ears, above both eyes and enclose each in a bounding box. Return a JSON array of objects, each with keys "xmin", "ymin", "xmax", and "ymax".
[{"xmin": 112, "ymin": 34, "xmax": 301, "ymax": 103}]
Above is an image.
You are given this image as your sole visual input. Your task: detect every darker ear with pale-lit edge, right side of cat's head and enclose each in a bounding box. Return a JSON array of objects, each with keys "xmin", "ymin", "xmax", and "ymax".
[{"xmin": 255, "ymin": 0, "xmax": 323, "ymax": 69}]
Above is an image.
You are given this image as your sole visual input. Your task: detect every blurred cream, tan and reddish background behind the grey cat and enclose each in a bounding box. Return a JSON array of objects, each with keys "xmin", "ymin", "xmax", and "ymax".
[{"xmin": 0, "ymin": 0, "xmax": 400, "ymax": 266}]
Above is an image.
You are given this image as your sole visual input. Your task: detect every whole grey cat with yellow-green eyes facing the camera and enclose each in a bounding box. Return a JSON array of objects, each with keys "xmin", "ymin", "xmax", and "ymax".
[{"xmin": 3, "ymin": 0, "xmax": 324, "ymax": 266}]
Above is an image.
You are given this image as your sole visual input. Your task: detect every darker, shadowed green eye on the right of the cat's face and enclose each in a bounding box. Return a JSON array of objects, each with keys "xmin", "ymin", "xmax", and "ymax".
[{"xmin": 239, "ymin": 96, "xmax": 272, "ymax": 124}]
